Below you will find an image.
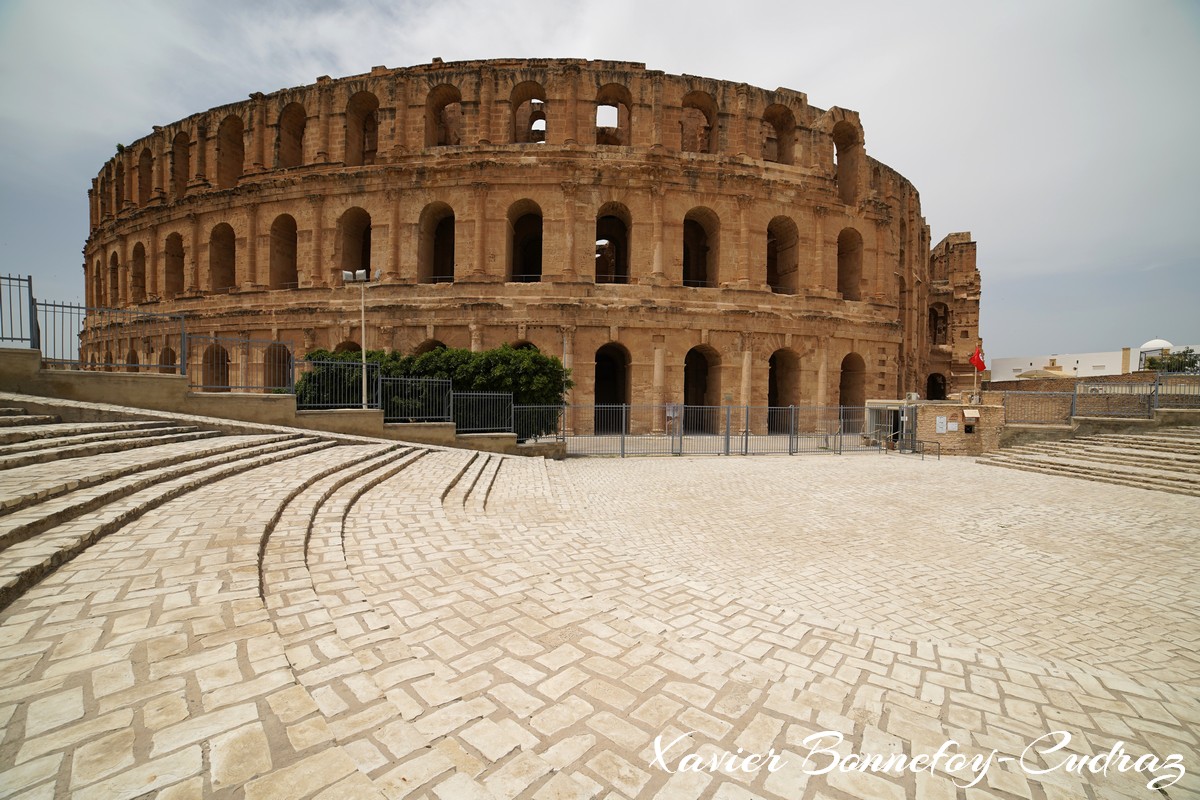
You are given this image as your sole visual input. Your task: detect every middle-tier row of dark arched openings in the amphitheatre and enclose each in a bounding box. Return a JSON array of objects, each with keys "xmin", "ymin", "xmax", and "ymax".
[{"xmin": 89, "ymin": 205, "xmax": 868, "ymax": 304}]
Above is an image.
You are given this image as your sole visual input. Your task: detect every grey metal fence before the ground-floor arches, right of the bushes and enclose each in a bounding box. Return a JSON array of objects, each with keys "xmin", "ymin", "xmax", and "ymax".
[{"xmin": 515, "ymin": 404, "xmax": 887, "ymax": 457}]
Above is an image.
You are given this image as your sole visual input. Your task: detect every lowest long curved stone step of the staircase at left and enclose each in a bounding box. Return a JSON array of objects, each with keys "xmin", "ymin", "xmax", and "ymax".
[{"xmin": 0, "ymin": 439, "xmax": 335, "ymax": 609}]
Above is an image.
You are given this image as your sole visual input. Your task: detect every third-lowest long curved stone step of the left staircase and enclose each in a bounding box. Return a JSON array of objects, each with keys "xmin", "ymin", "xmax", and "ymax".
[{"xmin": 0, "ymin": 433, "xmax": 301, "ymax": 517}]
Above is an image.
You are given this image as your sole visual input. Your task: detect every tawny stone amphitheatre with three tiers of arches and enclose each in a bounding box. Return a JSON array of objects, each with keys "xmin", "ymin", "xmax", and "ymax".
[{"xmin": 84, "ymin": 60, "xmax": 979, "ymax": 405}]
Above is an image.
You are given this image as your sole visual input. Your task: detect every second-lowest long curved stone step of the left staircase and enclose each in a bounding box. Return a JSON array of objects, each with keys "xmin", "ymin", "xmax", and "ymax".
[{"xmin": 0, "ymin": 435, "xmax": 328, "ymax": 551}]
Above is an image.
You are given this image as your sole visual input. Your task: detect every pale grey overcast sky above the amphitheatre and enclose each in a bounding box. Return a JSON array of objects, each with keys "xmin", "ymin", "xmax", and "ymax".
[{"xmin": 0, "ymin": 0, "xmax": 1200, "ymax": 357}]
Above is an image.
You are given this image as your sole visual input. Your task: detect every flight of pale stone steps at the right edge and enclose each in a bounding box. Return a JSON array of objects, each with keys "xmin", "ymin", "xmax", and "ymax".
[{"xmin": 979, "ymin": 427, "xmax": 1200, "ymax": 497}]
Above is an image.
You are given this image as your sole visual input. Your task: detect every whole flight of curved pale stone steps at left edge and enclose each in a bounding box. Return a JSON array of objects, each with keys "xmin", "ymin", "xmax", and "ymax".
[{"xmin": 0, "ymin": 408, "xmax": 336, "ymax": 608}]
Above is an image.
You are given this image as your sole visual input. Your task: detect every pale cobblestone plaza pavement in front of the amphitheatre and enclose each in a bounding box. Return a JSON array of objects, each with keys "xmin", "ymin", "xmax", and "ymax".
[{"xmin": 0, "ymin": 445, "xmax": 1200, "ymax": 800}]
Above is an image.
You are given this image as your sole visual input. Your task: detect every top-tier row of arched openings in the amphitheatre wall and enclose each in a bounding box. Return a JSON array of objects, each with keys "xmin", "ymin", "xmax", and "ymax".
[{"xmin": 97, "ymin": 80, "xmax": 865, "ymax": 218}]
